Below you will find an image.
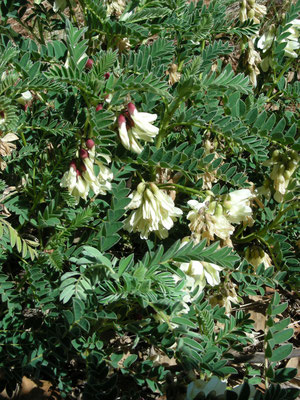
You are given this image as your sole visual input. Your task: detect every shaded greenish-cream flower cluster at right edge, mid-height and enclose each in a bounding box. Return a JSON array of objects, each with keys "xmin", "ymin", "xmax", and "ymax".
[{"xmin": 258, "ymin": 150, "xmax": 300, "ymax": 203}]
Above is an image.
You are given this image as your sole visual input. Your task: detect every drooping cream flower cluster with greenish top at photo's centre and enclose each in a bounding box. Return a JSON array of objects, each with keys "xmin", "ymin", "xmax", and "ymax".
[{"xmin": 124, "ymin": 182, "xmax": 182, "ymax": 239}]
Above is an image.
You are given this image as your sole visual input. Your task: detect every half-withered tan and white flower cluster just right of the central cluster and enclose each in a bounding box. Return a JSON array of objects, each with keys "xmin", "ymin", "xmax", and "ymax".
[{"xmin": 187, "ymin": 189, "xmax": 254, "ymax": 246}]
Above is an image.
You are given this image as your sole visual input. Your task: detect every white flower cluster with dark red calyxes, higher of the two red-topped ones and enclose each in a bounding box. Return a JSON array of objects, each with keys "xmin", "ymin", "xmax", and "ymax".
[{"xmin": 118, "ymin": 103, "xmax": 159, "ymax": 154}]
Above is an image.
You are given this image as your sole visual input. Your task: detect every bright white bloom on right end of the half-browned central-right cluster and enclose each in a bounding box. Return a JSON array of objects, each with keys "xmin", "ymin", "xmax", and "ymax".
[{"xmin": 223, "ymin": 189, "xmax": 254, "ymax": 224}]
